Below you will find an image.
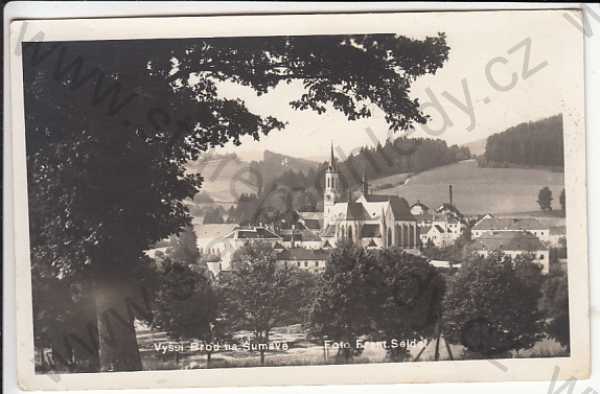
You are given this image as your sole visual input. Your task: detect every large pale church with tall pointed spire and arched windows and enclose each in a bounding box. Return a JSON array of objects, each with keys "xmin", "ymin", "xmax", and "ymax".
[{"xmin": 321, "ymin": 147, "xmax": 419, "ymax": 249}]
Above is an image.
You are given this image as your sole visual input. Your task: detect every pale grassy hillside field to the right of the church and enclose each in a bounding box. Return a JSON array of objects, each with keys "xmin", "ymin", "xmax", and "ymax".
[{"xmin": 372, "ymin": 160, "xmax": 564, "ymax": 214}]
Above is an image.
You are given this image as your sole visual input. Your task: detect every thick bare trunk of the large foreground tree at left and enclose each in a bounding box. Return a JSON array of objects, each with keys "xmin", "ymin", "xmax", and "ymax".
[{"xmin": 94, "ymin": 264, "xmax": 142, "ymax": 372}]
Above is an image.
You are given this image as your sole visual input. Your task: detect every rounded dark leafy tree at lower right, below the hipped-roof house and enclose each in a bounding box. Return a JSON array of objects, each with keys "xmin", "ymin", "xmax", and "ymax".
[{"xmin": 443, "ymin": 253, "xmax": 543, "ymax": 357}]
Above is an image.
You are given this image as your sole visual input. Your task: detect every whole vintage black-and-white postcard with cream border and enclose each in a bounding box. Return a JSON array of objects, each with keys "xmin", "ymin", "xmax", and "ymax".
[{"xmin": 7, "ymin": 10, "xmax": 590, "ymax": 390}]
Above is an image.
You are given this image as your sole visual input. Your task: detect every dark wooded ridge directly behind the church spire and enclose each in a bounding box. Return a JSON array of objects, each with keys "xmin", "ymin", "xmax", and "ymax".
[{"xmin": 214, "ymin": 137, "xmax": 471, "ymax": 225}]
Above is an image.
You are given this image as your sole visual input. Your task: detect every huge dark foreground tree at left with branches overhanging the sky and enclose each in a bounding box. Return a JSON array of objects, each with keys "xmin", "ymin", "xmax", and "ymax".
[{"xmin": 23, "ymin": 34, "xmax": 449, "ymax": 371}]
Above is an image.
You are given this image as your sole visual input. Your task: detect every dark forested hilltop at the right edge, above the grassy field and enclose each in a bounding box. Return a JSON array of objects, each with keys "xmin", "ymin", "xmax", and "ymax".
[{"xmin": 479, "ymin": 114, "xmax": 564, "ymax": 167}]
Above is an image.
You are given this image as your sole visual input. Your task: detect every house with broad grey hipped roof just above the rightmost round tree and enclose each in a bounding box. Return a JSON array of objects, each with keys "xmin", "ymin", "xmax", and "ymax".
[{"xmin": 470, "ymin": 230, "xmax": 550, "ymax": 274}]
